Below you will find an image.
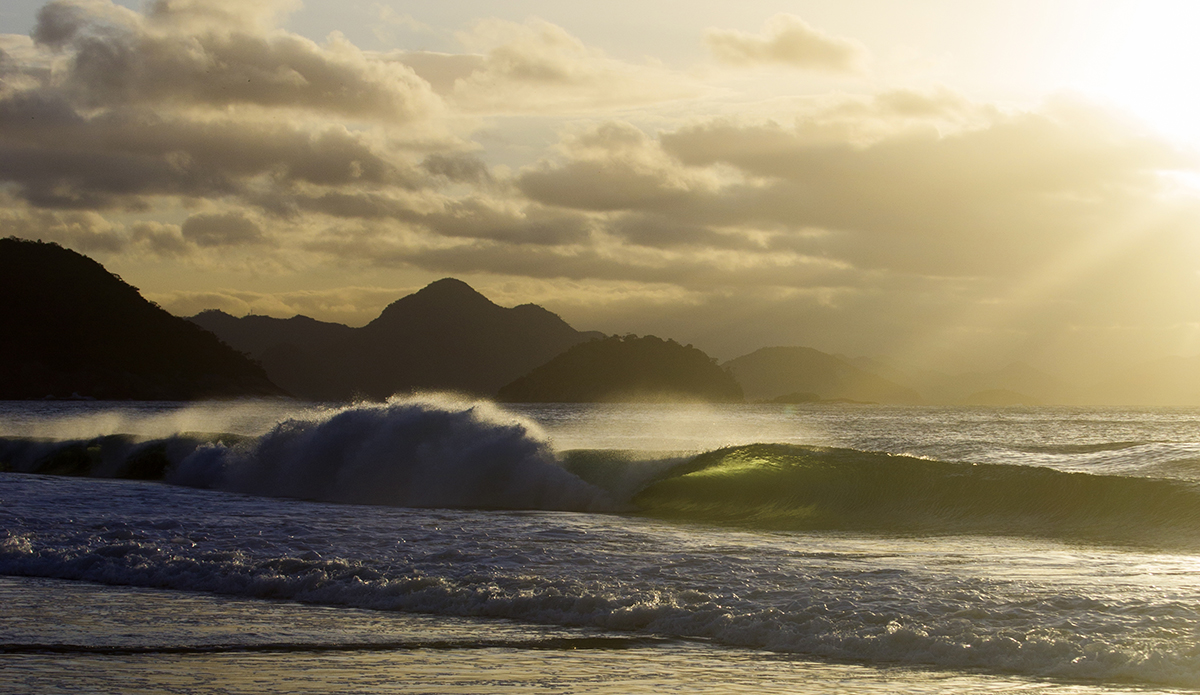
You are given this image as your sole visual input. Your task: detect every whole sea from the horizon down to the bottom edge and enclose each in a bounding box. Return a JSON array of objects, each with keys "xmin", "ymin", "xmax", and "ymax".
[{"xmin": 0, "ymin": 395, "xmax": 1200, "ymax": 694}]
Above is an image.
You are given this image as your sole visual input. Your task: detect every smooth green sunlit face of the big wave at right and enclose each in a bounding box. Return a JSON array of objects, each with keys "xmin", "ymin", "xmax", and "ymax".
[{"xmin": 632, "ymin": 444, "xmax": 1200, "ymax": 547}]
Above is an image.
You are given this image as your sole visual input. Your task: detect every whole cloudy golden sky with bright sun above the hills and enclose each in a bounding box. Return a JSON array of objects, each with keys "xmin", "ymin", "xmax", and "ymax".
[{"xmin": 0, "ymin": 0, "xmax": 1200, "ymax": 377}]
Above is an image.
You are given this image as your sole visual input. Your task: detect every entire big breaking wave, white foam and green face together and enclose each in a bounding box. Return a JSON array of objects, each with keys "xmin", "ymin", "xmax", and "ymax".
[{"xmin": 7, "ymin": 396, "xmax": 1200, "ymax": 547}]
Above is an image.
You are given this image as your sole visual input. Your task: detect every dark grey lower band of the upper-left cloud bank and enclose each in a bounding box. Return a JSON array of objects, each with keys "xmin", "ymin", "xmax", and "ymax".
[{"xmin": 0, "ymin": 91, "xmax": 420, "ymax": 209}]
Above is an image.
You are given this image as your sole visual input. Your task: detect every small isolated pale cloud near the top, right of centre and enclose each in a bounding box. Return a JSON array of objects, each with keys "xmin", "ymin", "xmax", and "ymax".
[{"xmin": 704, "ymin": 14, "xmax": 869, "ymax": 73}]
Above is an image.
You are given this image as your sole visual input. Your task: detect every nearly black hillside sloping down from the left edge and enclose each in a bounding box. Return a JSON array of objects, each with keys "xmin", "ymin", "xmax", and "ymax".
[{"xmin": 0, "ymin": 238, "xmax": 283, "ymax": 400}]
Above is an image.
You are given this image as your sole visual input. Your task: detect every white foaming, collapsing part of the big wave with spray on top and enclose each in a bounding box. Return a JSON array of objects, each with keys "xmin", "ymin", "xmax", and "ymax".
[{"xmin": 166, "ymin": 396, "xmax": 612, "ymax": 510}]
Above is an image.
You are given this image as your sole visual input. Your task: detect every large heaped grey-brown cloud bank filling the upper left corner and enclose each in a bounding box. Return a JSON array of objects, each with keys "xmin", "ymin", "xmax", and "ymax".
[{"xmin": 0, "ymin": 0, "xmax": 446, "ymax": 214}]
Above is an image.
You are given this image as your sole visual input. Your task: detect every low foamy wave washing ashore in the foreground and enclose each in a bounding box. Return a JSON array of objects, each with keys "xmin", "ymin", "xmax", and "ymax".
[{"xmin": 0, "ymin": 528, "xmax": 1200, "ymax": 688}]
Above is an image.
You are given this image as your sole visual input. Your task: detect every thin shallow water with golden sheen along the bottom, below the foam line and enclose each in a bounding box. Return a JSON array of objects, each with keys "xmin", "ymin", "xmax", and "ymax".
[{"xmin": 0, "ymin": 579, "xmax": 1166, "ymax": 695}]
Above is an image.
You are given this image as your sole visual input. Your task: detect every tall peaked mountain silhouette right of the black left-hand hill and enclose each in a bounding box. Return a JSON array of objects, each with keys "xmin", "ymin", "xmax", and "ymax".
[{"xmin": 199, "ymin": 278, "xmax": 602, "ymax": 400}]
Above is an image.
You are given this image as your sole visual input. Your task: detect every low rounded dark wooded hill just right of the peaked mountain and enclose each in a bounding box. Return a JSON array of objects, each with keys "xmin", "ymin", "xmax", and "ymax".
[{"xmin": 498, "ymin": 335, "xmax": 742, "ymax": 403}]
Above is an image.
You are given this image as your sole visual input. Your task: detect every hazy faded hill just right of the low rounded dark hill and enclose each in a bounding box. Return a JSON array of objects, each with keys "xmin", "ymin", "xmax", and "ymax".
[{"xmin": 724, "ymin": 347, "xmax": 923, "ymax": 403}]
